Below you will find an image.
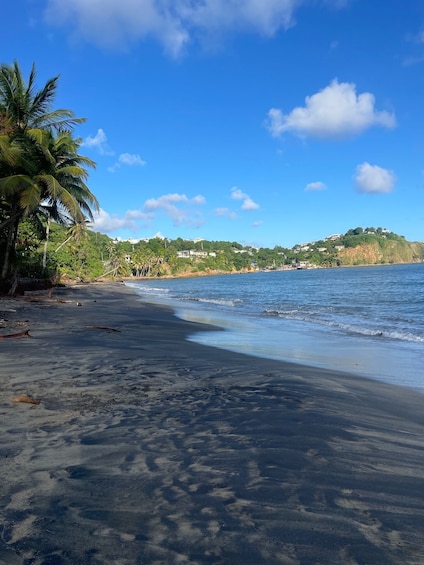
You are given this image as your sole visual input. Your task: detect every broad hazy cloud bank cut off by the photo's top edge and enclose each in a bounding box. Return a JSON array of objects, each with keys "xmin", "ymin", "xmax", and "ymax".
[{"xmin": 45, "ymin": 0, "xmax": 314, "ymax": 56}]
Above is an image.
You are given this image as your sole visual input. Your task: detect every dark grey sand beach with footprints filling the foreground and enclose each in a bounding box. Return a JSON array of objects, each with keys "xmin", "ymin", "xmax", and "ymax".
[{"xmin": 0, "ymin": 284, "xmax": 424, "ymax": 565}]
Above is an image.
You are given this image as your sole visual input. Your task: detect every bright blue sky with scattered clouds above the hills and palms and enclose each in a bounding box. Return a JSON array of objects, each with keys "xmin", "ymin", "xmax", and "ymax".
[{"xmin": 1, "ymin": 0, "xmax": 424, "ymax": 247}]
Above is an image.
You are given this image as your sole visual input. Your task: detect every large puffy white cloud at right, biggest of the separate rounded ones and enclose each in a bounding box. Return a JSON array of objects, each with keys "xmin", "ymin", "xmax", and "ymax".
[{"xmin": 267, "ymin": 79, "xmax": 396, "ymax": 139}]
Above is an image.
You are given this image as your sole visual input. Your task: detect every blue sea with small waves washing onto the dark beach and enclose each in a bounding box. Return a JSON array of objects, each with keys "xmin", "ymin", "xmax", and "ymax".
[{"xmin": 127, "ymin": 264, "xmax": 424, "ymax": 392}]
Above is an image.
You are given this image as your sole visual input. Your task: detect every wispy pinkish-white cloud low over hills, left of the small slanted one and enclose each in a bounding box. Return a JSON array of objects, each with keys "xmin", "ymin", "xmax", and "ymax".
[{"xmin": 143, "ymin": 193, "xmax": 206, "ymax": 227}]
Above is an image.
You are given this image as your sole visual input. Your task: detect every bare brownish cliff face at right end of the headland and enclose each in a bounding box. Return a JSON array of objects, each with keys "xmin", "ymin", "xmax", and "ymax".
[{"xmin": 338, "ymin": 241, "xmax": 424, "ymax": 265}]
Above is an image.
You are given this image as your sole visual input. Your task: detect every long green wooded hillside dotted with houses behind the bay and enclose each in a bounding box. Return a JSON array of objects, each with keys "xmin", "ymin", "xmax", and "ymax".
[{"xmin": 5, "ymin": 222, "xmax": 424, "ymax": 283}]
